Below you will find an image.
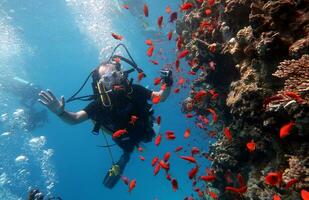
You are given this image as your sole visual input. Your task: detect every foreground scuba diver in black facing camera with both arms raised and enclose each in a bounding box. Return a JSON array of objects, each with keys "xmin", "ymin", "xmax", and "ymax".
[{"xmin": 38, "ymin": 44, "xmax": 173, "ymax": 189}]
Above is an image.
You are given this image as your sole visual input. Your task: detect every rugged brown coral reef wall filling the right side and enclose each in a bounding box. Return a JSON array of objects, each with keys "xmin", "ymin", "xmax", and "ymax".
[{"xmin": 177, "ymin": 0, "xmax": 309, "ymax": 200}]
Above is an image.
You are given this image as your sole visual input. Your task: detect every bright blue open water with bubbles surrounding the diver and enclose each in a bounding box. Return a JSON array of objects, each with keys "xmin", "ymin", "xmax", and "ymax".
[{"xmin": 0, "ymin": 0, "xmax": 209, "ymax": 200}]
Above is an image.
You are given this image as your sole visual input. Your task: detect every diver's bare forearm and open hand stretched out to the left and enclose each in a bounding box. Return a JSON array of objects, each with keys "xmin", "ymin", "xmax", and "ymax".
[{"xmin": 38, "ymin": 90, "xmax": 88, "ymax": 124}]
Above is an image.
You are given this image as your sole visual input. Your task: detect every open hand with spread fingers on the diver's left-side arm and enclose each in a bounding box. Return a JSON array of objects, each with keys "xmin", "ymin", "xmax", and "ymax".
[{"xmin": 38, "ymin": 89, "xmax": 65, "ymax": 115}]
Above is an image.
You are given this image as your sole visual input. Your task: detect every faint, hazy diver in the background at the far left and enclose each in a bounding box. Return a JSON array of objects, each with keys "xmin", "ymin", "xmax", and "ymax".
[{"xmin": 0, "ymin": 76, "xmax": 48, "ymax": 131}]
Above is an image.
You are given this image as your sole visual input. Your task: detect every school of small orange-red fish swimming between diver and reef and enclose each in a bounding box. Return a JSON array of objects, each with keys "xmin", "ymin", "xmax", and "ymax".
[{"xmin": 111, "ymin": 0, "xmax": 309, "ymax": 200}]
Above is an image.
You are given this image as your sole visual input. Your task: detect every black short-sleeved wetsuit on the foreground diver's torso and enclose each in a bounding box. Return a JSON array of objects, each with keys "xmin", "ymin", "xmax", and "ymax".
[{"xmin": 83, "ymin": 84, "xmax": 155, "ymax": 153}]
